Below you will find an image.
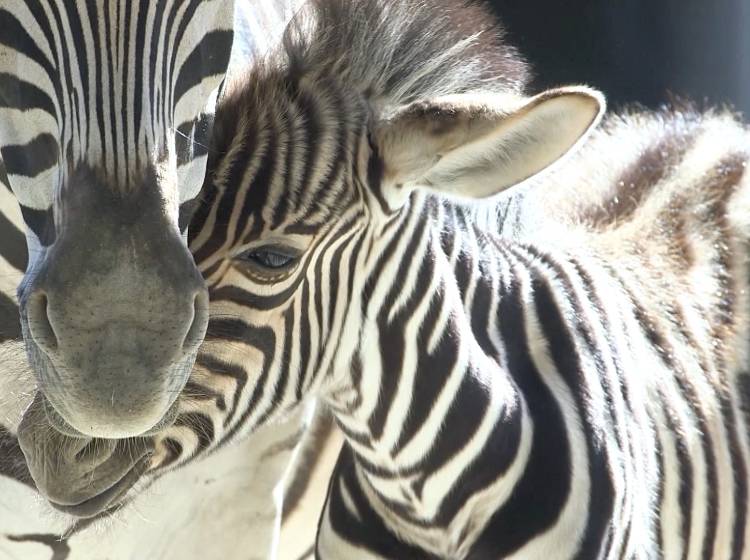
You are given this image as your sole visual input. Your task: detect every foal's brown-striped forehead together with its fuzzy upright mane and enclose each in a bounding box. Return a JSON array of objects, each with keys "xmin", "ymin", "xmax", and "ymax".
[{"xmin": 206, "ymin": 0, "xmax": 527, "ymax": 240}]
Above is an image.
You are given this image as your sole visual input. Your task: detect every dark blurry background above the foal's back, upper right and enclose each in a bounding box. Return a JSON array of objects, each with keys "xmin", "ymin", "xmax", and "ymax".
[{"xmin": 488, "ymin": 0, "xmax": 750, "ymax": 118}]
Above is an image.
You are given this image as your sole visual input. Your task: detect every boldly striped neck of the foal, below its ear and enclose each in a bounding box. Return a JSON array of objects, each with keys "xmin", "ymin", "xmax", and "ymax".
[{"xmin": 331, "ymin": 196, "xmax": 548, "ymax": 556}]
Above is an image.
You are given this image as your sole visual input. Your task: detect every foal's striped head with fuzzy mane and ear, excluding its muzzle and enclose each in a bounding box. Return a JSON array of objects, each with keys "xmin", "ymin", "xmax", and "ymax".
[{"xmin": 191, "ymin": 0, "xmax": 603, "ymax": 442}]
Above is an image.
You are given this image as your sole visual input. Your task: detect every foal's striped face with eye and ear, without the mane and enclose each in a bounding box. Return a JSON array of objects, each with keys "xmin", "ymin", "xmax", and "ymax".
[{"xmin": 191, "ymin": 57, "xmax": 602, "ymax": 444}]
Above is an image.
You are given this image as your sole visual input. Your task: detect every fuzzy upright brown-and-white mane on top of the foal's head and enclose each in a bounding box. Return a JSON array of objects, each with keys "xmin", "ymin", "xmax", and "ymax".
[{"xmin": 279, "ymin": 0, "xmax": 528, "ymax": 108}]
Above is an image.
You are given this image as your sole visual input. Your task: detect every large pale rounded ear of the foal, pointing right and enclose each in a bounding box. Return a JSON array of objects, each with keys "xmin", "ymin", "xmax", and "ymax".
[{"xmin": 375, "ymin": 87, "xmax": 605, "ymax": 207}]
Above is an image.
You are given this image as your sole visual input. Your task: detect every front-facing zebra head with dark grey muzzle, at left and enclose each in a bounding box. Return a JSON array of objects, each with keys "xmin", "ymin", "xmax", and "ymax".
[{"xmin": 0, "ymin": 0, "xmax": 233, "ymax": 438}]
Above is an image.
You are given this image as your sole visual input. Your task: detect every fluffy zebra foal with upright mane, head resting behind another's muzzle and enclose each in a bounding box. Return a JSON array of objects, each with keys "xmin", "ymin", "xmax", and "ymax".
[{"xmin": 193, "ymin": 0, "xmax": 750, "ymax": 560}]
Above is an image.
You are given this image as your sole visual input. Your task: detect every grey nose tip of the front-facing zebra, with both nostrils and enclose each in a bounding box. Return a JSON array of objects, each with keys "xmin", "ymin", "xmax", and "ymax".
[{"xmin": 26, "ymin": 283, "xmax": 208, "ymax": 438}]
